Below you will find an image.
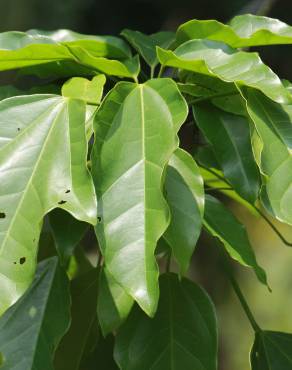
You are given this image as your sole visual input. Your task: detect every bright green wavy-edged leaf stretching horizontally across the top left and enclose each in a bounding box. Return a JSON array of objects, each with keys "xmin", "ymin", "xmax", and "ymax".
[{"xmin": 0, "ymin": 30, "xmax": 138, "ymax": 77}]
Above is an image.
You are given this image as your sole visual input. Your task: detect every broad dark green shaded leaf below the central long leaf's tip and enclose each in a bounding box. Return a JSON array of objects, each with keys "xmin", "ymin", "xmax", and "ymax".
[{"xmin": 115, "ymin": 274, "xmax": 217, "ymax": 370}]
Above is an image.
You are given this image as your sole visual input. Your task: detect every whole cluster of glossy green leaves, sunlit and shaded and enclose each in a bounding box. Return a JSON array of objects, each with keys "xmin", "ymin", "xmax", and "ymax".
[{"xmin": 0, "ymin": 15, "xmax": 292, "ymax": 370}]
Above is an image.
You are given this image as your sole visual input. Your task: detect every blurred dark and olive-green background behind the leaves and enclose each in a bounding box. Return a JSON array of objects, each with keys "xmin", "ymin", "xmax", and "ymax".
[{"xmin": 0, "ymin": 0, "xmax": 292, "ymax": 370}]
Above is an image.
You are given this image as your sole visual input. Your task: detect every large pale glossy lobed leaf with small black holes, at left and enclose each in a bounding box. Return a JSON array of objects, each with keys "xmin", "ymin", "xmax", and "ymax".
[{"xmin": 0, "ymin": 95, "xmax": 96, "ymax": 314}]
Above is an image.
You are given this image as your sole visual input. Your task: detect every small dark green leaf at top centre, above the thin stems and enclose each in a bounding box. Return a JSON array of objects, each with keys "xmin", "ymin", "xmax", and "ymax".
[{"xmin": 121, "ymin": 29, "xmax": 175, "ymax": 69}]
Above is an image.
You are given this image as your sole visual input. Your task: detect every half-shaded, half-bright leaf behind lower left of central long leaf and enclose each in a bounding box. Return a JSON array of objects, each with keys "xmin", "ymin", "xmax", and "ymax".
[{"xmin": 97, "ymin": 268, "xmax": 134, "ymax": 336}]
